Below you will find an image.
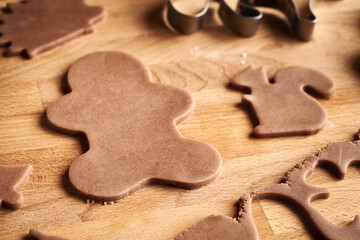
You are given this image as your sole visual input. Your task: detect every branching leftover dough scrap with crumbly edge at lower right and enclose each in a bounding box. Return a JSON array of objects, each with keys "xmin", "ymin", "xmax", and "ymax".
[{"xmin": 242, "ymin": 132, "xmax": 360, "ymax": 240}]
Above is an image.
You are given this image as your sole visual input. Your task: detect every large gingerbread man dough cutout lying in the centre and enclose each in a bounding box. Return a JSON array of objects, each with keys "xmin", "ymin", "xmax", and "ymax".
[{"xmin": 47, "ymin": 52, "xmax": 221, "ymax": 202}]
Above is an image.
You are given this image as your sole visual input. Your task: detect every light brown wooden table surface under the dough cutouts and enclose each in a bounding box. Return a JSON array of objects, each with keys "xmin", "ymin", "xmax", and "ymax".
[{"xmin": 0, "ymin": 0, "xmax": 360, "ymax": 240}]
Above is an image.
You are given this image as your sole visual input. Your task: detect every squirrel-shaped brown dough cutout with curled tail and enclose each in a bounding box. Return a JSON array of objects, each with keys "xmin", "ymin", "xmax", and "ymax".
[{"xmin": 231, "ymin": 66, "xmax": 335, "ymax": 137}]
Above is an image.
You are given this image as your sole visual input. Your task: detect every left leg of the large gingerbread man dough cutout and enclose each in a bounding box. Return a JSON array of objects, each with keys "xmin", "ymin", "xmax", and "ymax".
[{"xmin": 69, "ymin": 150, "xmax": 150, "ymax": 201}]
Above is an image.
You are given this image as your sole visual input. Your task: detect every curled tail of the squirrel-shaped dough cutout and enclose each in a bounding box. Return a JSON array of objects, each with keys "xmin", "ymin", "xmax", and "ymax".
[{"xmin": 274, "ymin": 66, "xmax": 335, "ymax": 99}]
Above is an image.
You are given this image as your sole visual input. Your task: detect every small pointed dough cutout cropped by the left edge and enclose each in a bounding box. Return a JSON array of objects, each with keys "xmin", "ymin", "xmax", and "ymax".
[{"xmin": 0, "ymin": 165, "xmax": 32, "ymax": 209}]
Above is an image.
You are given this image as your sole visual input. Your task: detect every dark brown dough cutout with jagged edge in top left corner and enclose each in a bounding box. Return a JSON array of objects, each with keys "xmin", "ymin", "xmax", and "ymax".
[{"xmin": 0, "ymin": 0, "xmax": 105, "ymax": 58}]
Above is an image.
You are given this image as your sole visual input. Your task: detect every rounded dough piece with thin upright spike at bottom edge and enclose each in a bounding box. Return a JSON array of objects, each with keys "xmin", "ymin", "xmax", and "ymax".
[{"xmin": 175, "ymin": 195, "xmax": 259, "ymax": 240}]
